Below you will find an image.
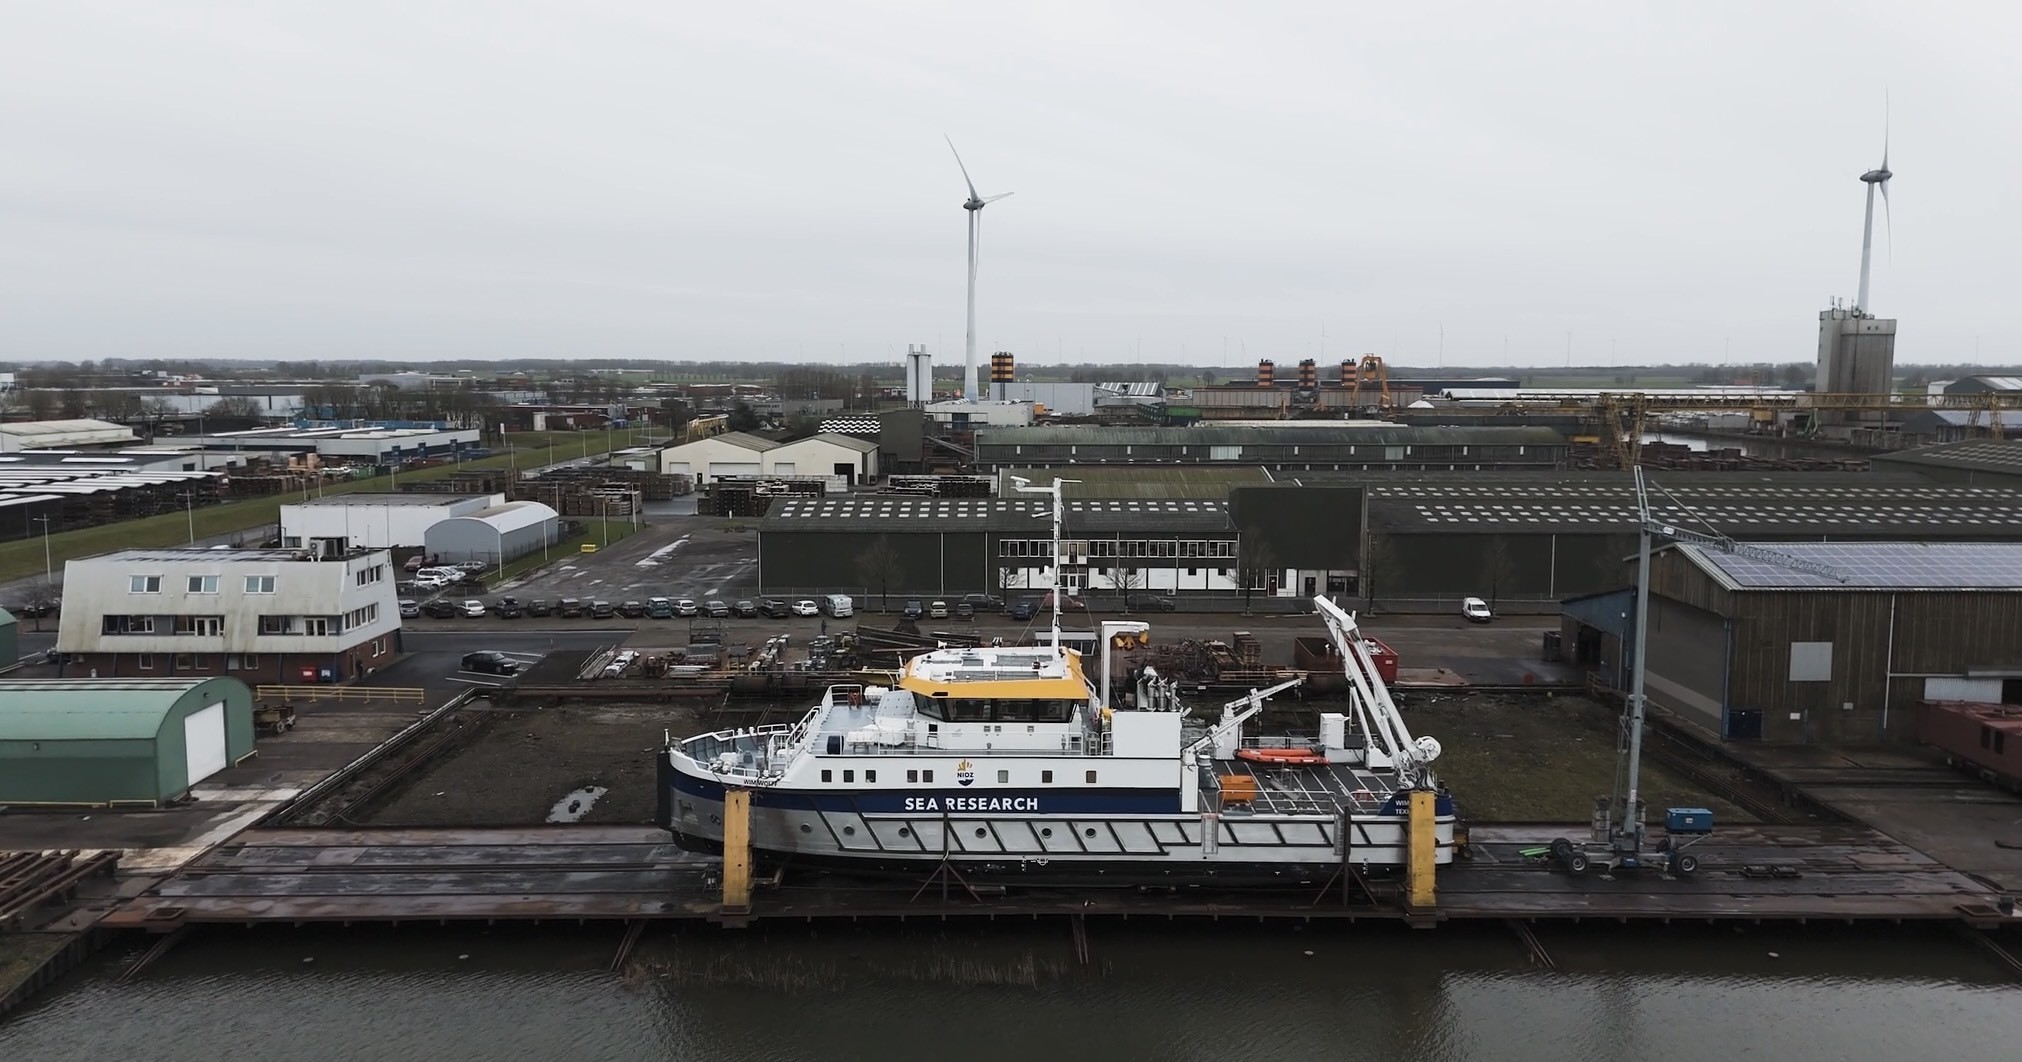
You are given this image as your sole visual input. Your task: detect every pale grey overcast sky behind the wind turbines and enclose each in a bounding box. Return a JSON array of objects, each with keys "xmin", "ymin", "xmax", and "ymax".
[{"xmin": 0, "ymin": 0, "xmax": 2022, "ymax": 366}]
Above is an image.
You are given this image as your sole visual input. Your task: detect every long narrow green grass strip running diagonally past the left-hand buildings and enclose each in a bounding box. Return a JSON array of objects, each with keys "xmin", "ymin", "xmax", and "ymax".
[{"xmin": 0, "ymin": 431, "xmax": 629, "ymax": 583}]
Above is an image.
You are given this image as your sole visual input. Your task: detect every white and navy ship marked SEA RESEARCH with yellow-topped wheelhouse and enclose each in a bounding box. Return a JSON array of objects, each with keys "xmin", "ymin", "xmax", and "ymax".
[{"xmin": 659, "ymin": 481, "xmax": 1454, "ymax": 886}]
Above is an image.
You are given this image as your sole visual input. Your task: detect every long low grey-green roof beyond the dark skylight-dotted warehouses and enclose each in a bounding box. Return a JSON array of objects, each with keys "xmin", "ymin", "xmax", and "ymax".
[{"xmin": 977, "ymin": 421, "xmax": 1565, "ymax": 447}]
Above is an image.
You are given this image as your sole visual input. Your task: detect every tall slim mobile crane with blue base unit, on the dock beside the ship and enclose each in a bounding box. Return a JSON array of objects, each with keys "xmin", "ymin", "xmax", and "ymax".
[{"xmin": 1551, "ymin": 465, "xmax": 1846, "ymax": 878}]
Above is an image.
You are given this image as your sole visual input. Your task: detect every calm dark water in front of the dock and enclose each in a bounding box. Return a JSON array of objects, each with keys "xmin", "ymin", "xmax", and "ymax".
[{"xmin": 0, "ymin": 922, "xmax": 2022, "ymax": 1062}]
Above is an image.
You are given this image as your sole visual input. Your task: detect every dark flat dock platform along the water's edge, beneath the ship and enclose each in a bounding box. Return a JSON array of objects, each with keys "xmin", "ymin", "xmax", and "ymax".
[{"xmin": 101, "ymin": 825, "xmax": 2004, "ymax": 931}]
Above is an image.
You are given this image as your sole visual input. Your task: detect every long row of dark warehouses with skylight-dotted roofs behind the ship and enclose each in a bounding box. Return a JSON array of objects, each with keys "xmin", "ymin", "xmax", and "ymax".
[{"xmin": 758, "ymin": 443, "xmax": 2022, "ymax": 609}]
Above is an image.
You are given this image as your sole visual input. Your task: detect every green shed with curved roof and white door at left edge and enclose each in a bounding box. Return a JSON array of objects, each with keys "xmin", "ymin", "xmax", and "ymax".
[{"xmin": 0, "ymin": 678, "xmax": 253, "ymax": 805}]
